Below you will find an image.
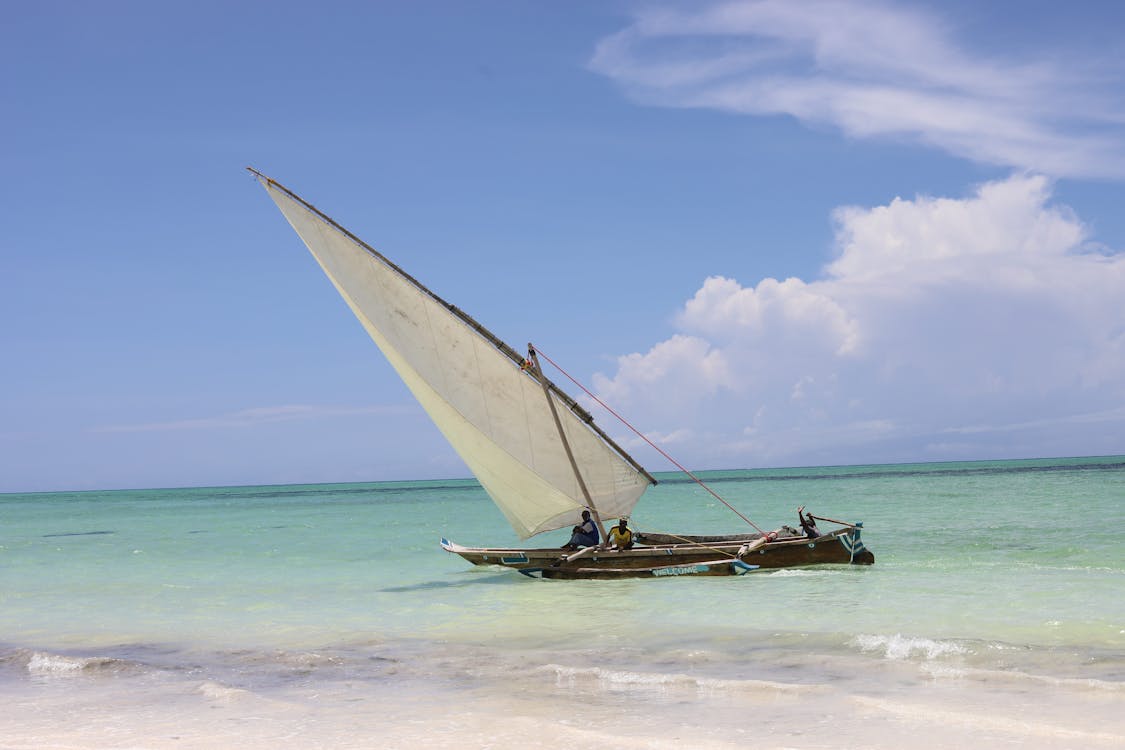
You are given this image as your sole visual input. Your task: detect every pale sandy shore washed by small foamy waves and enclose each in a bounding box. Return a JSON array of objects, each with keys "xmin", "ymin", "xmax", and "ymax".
[{"xmin": 0, "ymin": 643, "xmax": 1125, "ymax": 750}]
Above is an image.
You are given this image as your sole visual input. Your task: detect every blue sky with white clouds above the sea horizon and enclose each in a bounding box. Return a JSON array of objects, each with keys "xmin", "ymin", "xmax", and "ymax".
[{"xmin": 0, "ymin": 0, "xmax": 1125, "ymax": 493}]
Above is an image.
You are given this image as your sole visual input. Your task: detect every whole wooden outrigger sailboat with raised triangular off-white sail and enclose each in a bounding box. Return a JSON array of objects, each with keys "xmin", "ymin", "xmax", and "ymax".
[{"xmin": 248, "ymin": 168, "xmax": 874, "ymax": 578}]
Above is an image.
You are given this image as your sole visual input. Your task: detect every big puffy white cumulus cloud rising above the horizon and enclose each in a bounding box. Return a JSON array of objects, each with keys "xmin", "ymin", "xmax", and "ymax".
[{"xmin": 594, "ymin": 175, "xmax": 1125, "ymax": 467}]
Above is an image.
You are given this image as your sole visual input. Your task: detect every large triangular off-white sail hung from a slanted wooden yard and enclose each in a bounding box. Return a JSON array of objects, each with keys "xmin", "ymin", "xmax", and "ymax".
[{"xmin": 259, "ymin": 175, "xmax": 650, "ymax": 539}]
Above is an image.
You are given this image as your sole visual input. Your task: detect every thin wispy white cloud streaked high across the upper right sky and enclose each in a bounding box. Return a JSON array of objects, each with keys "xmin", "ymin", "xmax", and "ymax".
[{"xmin": 591, "ymin": 0, "xmax": 1125, "ymax": 177}]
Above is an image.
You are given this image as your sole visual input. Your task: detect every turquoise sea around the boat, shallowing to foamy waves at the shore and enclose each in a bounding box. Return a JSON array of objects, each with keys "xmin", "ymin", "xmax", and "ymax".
[{"xmin": 0, "ymin": 457, "xmax": 1125, "ymax": 750}]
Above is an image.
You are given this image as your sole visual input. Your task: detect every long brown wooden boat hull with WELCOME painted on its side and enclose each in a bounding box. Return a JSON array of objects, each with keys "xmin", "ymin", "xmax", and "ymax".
[{"xmin": 441, "ymin": 525, "xmax": 875, "ymax": 578}]
